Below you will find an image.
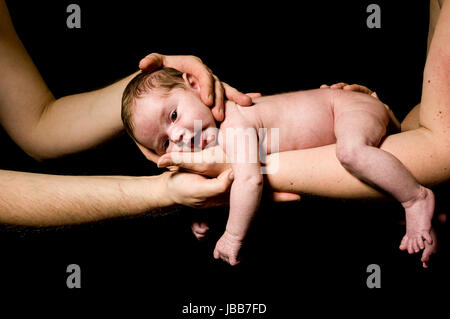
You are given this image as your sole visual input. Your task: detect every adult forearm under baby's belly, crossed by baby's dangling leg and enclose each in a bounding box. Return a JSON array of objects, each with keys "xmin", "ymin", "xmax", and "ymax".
[{"xmin": 266, "ymin": 128, "xmax": 450, "ymax": 198}]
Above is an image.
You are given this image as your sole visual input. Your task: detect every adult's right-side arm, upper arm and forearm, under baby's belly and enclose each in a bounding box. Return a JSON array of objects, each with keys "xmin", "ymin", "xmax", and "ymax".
[{"xmin": 267, "ymin": 1, "xmax": 450, "ymax": 198}]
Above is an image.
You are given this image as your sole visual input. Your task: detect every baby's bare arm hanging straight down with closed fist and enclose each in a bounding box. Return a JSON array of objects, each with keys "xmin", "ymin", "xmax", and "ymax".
[{"xmin": 214, "ymin": 128, "xmax": 263, "ymax": 266}]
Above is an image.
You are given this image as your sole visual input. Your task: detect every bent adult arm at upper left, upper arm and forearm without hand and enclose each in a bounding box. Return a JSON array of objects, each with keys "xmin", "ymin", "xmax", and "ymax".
[{"xmin": 0, "ymin": 1, "xmax": 137, "ymax": 159}]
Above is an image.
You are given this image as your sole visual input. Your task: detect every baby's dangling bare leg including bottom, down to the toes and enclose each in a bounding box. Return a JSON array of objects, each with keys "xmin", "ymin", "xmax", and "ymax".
[{"xmin": 334, "ymin": 99, "xmax": 434, "ymax": 253}]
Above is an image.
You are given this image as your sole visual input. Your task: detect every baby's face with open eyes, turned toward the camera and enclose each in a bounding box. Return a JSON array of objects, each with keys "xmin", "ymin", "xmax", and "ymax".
[{"xmin": 132, "ymin": 88, "xmax": 216, "ymax": 155}]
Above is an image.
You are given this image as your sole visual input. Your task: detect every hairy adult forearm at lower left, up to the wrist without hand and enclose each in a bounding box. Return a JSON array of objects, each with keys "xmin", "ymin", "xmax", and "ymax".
[{"xmin": 0, "ymin": 170, "xmax": 173, "ymax": 226}]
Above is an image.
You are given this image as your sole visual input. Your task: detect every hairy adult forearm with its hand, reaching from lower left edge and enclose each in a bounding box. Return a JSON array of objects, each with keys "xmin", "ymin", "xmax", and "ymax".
[{"xmin": 0, "ymin": 170, "xmax": 232, "ymax": 226}]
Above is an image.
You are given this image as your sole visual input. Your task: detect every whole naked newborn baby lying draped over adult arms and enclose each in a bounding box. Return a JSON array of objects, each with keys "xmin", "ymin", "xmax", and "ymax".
[{"xmin": 122, "ymin": 68, "xmax": 434, "ymax": 265}]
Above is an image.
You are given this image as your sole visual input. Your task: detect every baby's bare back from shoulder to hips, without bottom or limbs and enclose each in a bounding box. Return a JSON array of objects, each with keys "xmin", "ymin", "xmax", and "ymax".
[{"xmin": 221, "ymin": 89, "xmax": 336, "ymax": 154}]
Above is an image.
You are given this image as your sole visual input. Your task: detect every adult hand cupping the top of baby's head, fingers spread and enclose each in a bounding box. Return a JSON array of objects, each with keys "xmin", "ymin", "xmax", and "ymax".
[{"xmin": 139, "ymin": 53, "xmax": 252, "ymax": 122}]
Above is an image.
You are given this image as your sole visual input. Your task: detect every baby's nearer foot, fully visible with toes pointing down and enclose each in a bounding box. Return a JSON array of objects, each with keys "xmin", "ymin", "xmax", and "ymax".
[{"xmin": 400, "ymin": 186, "xmax": 434, "ymax": 254}]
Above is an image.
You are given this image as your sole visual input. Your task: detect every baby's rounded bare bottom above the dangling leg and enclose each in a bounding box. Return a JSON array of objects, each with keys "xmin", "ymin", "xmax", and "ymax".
[{"xmin": 334, "ymin": 96, "xmax": 389, "ymax": 145}]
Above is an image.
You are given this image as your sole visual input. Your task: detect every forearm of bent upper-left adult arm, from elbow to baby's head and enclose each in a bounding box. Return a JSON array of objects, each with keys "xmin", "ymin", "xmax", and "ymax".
[{"xmin": 26, "ymin": 74, "xmax": 139, "ymax": 159}]
